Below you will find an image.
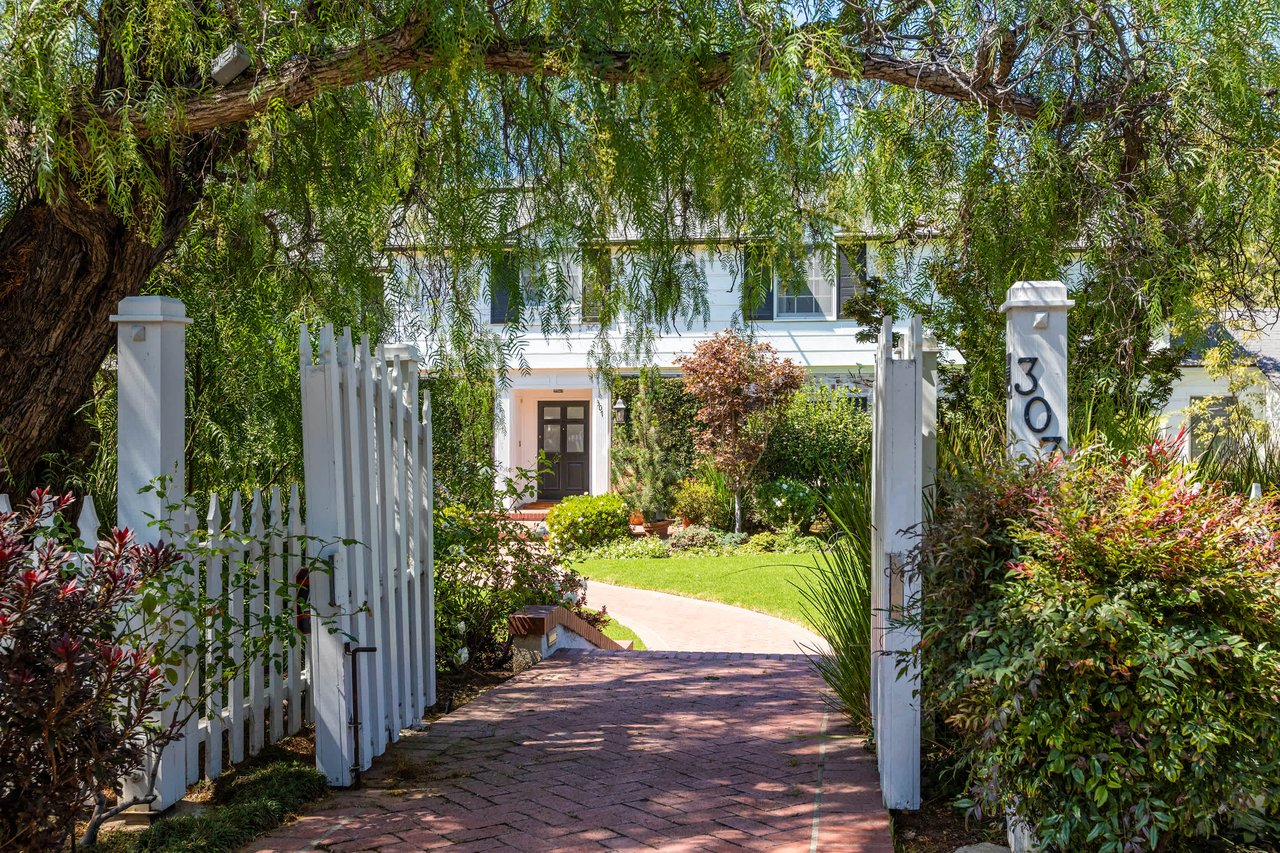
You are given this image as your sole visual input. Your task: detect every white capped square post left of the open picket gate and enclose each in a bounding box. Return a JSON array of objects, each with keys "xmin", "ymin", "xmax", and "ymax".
[{"xmin": 111, "ymin": 296, "xmax": 191, "ymax": 811}]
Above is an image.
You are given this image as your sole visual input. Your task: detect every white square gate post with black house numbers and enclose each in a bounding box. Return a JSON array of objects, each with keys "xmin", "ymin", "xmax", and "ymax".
[{"xmin": 1000, "ymin": 282, "xmax": 1075, "ymax": 457}]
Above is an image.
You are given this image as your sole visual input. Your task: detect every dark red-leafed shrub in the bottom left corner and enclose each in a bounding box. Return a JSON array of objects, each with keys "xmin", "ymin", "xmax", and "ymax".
[{"xmin": 0, "ymin": 491, "xmax": 175, "ymax": 852}]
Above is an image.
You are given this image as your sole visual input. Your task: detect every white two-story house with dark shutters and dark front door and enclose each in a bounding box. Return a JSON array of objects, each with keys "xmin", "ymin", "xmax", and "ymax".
[{"xmin": 465, "ymin": 243, "xmax": 877, "ymax": 501}]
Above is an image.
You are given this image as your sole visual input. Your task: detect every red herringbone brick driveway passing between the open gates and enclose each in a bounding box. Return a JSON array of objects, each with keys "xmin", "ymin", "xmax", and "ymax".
[{"xmin": 247, "ymin": 652, "xmax": 893, "ymax": 853}]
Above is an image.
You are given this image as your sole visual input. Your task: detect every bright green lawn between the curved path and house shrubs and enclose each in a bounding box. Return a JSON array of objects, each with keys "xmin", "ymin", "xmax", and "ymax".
[{"xmin": 573, "ymin": 553, "xmax": 815, "ymax": 628}]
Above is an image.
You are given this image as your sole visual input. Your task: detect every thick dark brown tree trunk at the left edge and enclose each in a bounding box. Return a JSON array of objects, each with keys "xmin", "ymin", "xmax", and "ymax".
[{"xmin": 0, "ymin": 145, "xmax": 214, "ymax": 493}]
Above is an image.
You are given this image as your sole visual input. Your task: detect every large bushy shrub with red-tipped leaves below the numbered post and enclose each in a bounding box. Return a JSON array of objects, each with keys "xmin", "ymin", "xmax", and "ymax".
[{"xmin": 920, "ymin": 443, "xmax": 1280, "ymax": 852}]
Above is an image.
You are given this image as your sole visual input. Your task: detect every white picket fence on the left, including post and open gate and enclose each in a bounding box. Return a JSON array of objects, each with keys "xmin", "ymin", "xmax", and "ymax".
[{"xmin": 0, "ymin": 296, "xmax": 435, "ymax": 811}]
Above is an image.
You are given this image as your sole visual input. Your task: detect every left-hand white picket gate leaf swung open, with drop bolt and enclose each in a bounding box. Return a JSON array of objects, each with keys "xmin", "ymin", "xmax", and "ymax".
[{"xmin": 301, "ymin": 325, "xmax": 435, "ymax": 785}]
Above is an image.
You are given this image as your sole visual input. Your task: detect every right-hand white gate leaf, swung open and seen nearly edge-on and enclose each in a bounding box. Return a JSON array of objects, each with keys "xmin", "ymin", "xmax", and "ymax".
[{"xmin": 870, "ymin": 316, "xmax": 938, "ymax": 809}]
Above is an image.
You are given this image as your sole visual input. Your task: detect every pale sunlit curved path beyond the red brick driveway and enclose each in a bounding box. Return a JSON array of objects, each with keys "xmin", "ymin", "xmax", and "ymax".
[{"xmin": 586, "ymin": 580, "xmax": 827, "ymax": 654}]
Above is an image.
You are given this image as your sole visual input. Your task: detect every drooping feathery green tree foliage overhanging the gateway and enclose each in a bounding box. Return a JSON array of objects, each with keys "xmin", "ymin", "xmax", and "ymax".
[{"xmin": 0, "ymin": 0, "xmax": 1280, "ymax": 491}]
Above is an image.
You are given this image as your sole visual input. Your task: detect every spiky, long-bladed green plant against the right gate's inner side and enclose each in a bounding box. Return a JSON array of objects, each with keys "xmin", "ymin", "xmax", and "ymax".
[{"xmin": 800, "ymin": 479, "xmax": 872, "ymax": 731}]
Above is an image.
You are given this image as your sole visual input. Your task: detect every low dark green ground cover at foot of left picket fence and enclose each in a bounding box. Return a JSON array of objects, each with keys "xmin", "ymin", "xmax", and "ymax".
[{"xmin": 100, "ymin": 747, "xmax": 329, "ymax": 853}]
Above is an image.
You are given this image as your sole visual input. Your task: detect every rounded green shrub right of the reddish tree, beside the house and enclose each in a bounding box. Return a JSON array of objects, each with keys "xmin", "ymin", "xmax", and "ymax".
[{"xmin": 762, "ymin": 382, "xmax": 872, "ymax": 485}]
